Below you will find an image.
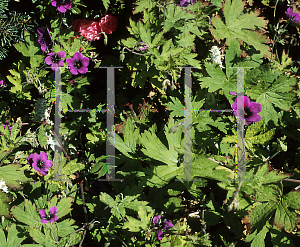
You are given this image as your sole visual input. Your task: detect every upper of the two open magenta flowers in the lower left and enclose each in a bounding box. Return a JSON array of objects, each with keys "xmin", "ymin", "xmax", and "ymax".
[{"xmin": 27, "ymin": 152, "xmax": 52, "ymax": 176}]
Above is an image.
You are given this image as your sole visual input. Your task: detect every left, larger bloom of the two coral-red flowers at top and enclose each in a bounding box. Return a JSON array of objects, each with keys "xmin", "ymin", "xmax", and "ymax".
[{"xmin": 73, "ymin": 19, "xmax": 102, "ymax": 41}]
